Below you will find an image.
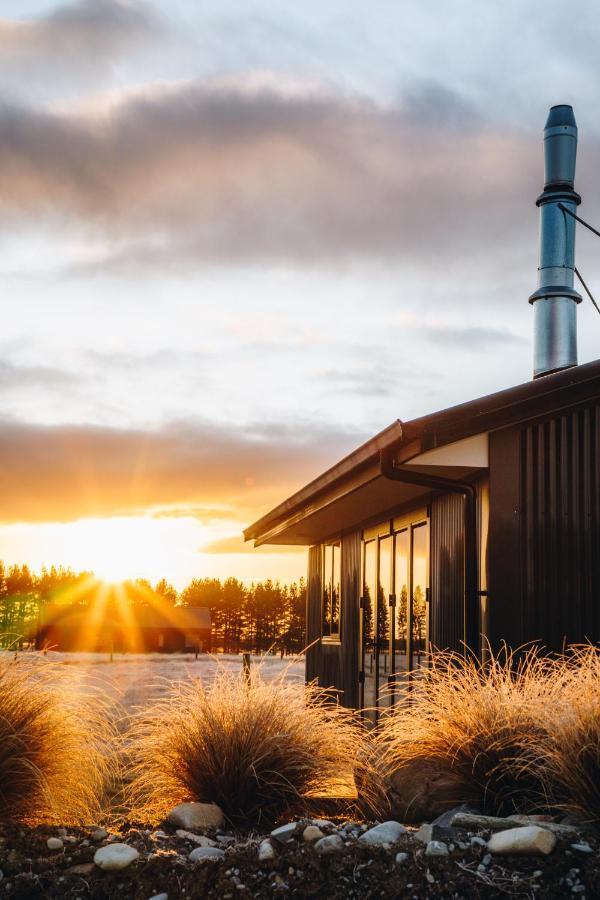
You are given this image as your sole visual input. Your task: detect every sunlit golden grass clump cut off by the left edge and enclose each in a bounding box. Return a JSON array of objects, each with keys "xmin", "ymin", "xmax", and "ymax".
[{"xmin": 0, "ymin": 651, "xmax": 114, "ymax": 825}]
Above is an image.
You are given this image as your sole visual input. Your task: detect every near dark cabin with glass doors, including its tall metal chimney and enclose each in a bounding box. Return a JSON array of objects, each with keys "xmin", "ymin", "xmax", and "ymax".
[{"xmin": 244, "ymin": 106, "xmax": 600, "ymax": 719}]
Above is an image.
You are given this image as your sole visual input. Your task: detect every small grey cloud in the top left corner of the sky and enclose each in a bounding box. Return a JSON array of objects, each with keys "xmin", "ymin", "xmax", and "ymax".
[{"xmin": 0, "ymin": 0, "xmax": 161, "ymax": 76}]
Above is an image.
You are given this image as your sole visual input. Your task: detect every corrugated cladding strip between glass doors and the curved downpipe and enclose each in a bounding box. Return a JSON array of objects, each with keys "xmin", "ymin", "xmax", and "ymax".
[{"xmin": 430, "ymin": 494, "xmax": 465, "ymax": 651}]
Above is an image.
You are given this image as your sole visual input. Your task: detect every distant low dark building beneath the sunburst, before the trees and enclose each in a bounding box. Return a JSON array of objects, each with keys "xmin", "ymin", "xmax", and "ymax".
[{"xmin": 35, "ymin": 602, "xmax": 211, "ymax": 653}]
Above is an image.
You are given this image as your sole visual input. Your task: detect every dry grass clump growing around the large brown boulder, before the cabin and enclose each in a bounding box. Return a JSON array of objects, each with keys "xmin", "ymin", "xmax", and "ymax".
[{"xmin": 377, "ymin": 650, "xmax": 556, "ymax": 821}]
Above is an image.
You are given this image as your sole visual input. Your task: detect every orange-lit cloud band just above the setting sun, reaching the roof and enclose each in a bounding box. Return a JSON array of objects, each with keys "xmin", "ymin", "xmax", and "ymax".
[{"xmin": 0, "ymin": 420, "xmax": 363, "ymax": 523}]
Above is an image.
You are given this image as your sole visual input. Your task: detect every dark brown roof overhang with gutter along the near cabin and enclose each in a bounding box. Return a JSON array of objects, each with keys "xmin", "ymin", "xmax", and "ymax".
[{"xmin": 244, "ymin": 360, "xmax": 600, "ymax": 546}]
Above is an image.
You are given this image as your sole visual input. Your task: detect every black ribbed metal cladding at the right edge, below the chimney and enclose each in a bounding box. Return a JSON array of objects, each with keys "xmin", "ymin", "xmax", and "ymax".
[{"xmin": 520, "ymin": 406, "xmax": 600, "ymax": 649}]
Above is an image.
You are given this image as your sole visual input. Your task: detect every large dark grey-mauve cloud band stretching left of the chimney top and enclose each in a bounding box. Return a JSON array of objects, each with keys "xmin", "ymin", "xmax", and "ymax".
[{"xmin": 0, "ymin": 81, "xmax": 568, "ymax": 274}]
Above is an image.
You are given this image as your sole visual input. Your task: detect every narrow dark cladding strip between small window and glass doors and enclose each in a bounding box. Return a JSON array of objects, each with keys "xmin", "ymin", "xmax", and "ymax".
[{"xmin": 340, "ymin": 531, "xmax": 361, "ymax": 707}]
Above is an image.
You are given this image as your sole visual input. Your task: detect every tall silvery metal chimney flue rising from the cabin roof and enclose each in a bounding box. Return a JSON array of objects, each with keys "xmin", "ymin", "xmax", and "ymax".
[{"xmin": 529, "ymin": 105, "xmax": 581, "ymax": 378}]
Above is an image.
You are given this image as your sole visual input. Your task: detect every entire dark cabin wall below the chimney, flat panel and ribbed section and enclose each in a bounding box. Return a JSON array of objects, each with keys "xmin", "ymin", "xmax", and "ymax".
[{"xmin": 490, "ymin": 404, "xmax": 600, "ymax": 650}]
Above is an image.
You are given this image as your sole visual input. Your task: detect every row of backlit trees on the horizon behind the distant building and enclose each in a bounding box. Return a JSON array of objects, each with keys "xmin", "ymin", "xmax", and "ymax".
[{"xmin": 0, "ymin": 561, "xmax": 306, "ymax": 654}]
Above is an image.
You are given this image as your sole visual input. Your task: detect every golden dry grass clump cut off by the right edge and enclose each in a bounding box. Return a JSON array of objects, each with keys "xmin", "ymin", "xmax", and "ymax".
[{"xmin": 526, "ymin": 645, "xmax": 600, "ymax": 823}]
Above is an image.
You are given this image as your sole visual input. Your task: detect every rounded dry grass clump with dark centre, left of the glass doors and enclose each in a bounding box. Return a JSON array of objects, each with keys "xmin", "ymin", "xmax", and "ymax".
[{"xmin": 127, "ymin": 667, "xmax": 374, "ymax": 826}]
